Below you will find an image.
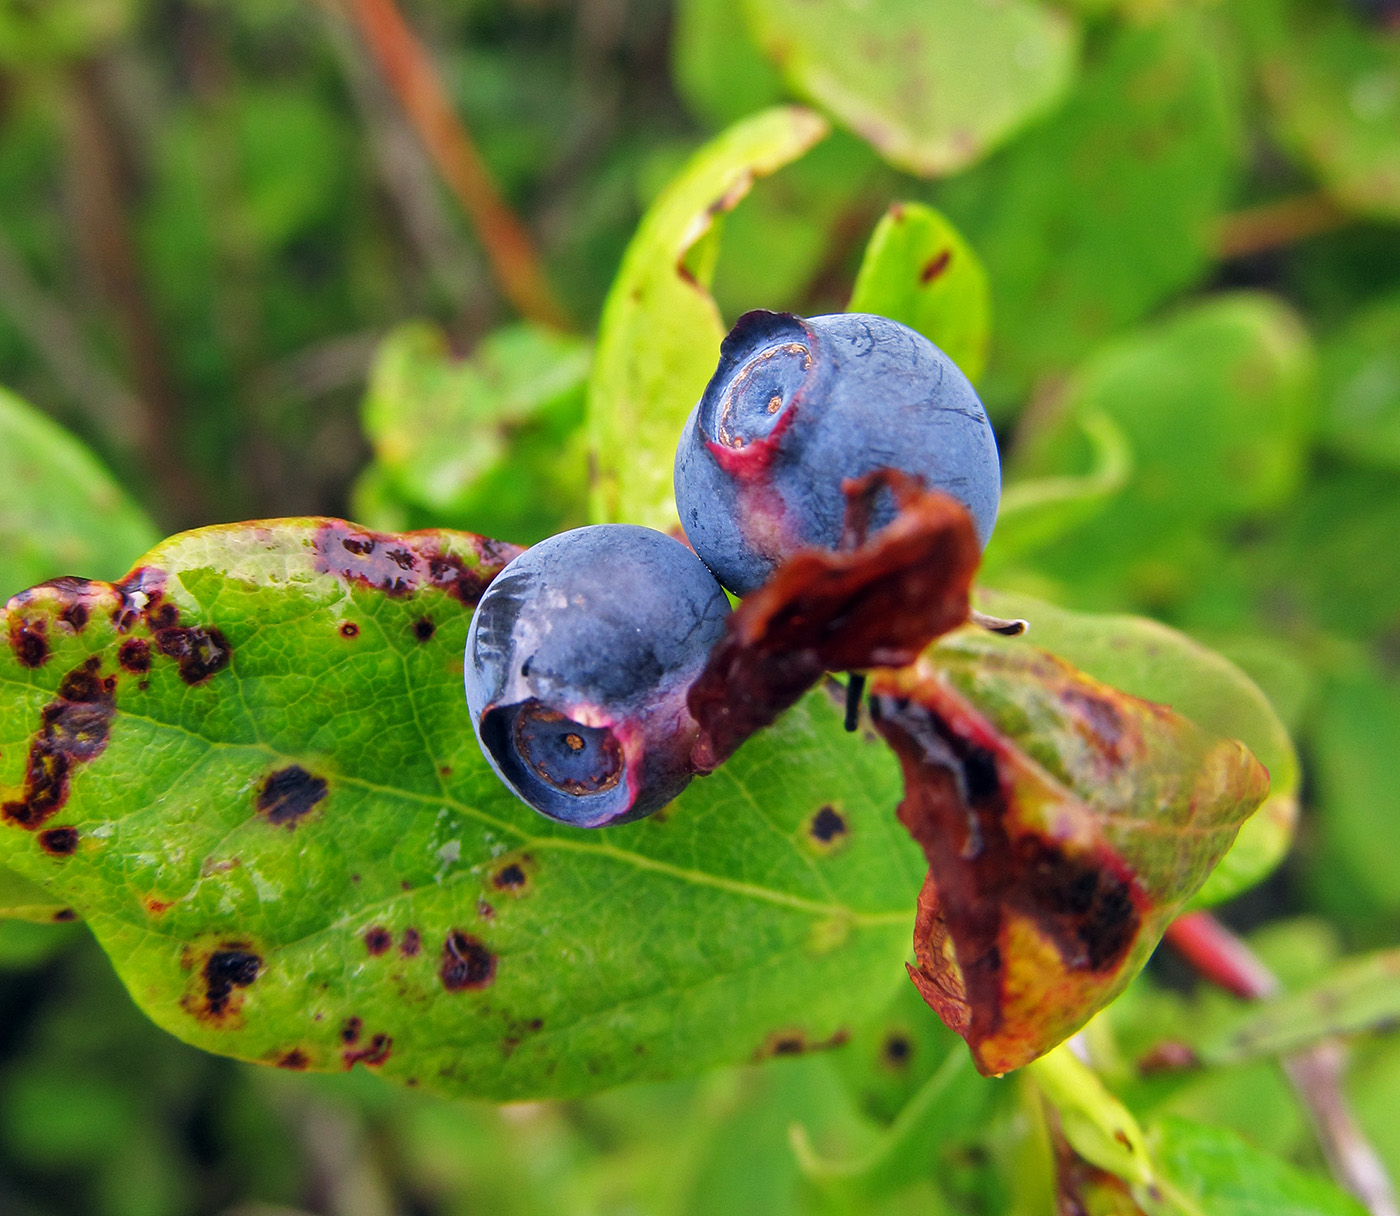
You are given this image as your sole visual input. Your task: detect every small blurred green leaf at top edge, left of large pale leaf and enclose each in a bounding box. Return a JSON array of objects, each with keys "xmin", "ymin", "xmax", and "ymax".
[{"xmin": 671, "ymin": 0, "xmax": 783, "ymax": 127}]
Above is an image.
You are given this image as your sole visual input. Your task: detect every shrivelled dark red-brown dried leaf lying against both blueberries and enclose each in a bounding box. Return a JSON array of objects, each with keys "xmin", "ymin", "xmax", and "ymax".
[{"xmin": 690, "ymin": 469, "xmax": 981, "ymax": 772}]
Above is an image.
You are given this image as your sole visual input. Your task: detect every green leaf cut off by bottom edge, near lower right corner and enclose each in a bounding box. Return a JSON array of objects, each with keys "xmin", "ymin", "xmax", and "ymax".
[{"xmin": 1148, "ymin": 1117, "xmax": 1365, "ymax": 1216}]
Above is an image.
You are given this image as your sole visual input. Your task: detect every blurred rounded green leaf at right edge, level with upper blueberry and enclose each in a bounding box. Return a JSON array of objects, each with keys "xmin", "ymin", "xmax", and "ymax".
[{"xmin": 1317, "ymin": 298, "xmax": 1400, "ymax": 469}]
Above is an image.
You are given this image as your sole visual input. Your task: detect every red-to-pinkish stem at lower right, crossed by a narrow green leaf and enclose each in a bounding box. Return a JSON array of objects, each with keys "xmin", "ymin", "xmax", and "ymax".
[{"xmin": 1166, "ymin": 912, "xmax": 1400, "ymax": 1216}]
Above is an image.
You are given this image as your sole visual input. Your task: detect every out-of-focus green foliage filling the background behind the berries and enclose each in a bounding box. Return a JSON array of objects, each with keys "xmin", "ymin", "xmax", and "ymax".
[{"xmin": 0, "ymin": 0, "xmax": 1400, "ymax": 1216}]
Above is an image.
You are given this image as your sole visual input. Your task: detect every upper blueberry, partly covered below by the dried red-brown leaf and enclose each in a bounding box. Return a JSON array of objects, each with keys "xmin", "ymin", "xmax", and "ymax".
[{"xmin": 675, "ymin": 312, "xmax": 1001, "ymax": 595}]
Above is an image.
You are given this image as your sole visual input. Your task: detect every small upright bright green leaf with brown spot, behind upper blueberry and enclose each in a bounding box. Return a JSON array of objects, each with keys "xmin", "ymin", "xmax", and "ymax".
[{"xmin": 848, "ymin": 203, "xmax": 991, "ymax": 381}]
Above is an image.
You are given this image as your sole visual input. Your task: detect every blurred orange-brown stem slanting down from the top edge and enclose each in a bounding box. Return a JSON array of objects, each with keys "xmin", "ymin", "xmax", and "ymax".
[{"xmin": 349, "ymin": 0, "xmax": 568, "ymax": 327}]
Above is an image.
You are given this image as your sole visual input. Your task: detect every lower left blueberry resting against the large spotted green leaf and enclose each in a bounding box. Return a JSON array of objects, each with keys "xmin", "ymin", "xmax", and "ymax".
[{"xmin": 465, "ymin": 523, "xmax": 729, "ymax": 827}]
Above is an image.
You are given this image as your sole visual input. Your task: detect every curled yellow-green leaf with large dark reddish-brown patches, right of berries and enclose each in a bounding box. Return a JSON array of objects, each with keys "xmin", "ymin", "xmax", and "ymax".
[{"xmin": 871, "ymin": 649, "xmax": 1268, "ymax": 1075}]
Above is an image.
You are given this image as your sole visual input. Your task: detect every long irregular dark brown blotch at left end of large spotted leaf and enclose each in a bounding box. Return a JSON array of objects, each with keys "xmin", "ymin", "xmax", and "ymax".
[{"xmin": 0, "ymin": 655, "xmax": 116, "ymax": 830}]
